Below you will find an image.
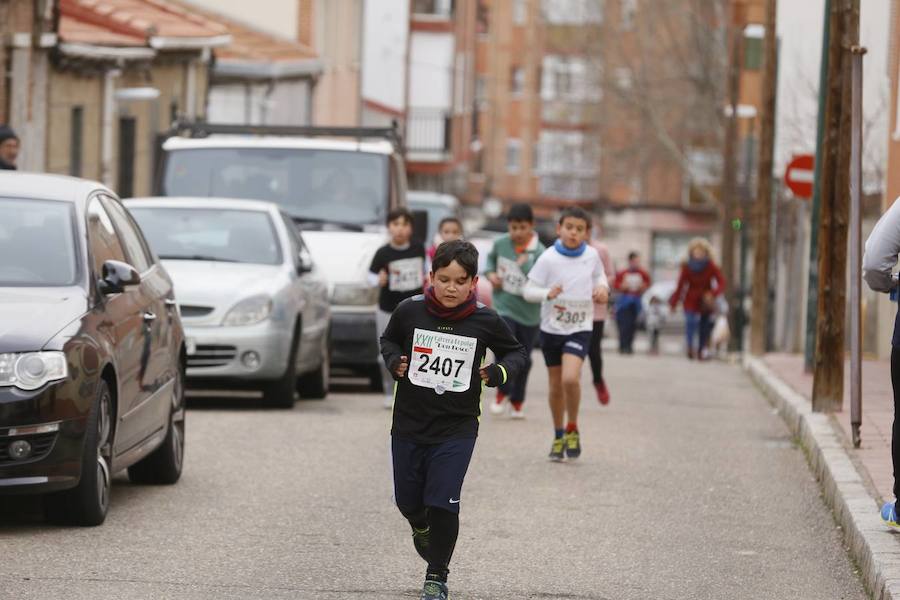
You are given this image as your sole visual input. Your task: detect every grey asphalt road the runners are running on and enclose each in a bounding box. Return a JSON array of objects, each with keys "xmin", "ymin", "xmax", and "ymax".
[{"xmin": 0, "ymin": 346, "xmax": 865, "ymax": 600}]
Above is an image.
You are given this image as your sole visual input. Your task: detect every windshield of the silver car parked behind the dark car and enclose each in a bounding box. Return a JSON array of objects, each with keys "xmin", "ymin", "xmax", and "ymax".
[{"xmin": 129, "ymin": 206, "xmax": 281, "ymax": 265}]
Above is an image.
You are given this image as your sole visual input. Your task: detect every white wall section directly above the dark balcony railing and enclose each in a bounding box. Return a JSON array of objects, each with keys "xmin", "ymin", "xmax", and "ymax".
[{"xmin": 409, "ymin": 32, "xmax": 454, "ymax": 110}]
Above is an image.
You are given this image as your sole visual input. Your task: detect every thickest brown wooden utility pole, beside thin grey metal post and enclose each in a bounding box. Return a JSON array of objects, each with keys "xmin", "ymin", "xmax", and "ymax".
[{"xmin": 812, "ymin": 0, "xmax": 859, "ymax": 412}]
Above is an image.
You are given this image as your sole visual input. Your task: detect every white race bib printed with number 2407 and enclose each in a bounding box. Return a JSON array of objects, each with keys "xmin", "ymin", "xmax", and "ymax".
[{"xmin": 409, "ymin": 329, "xmax": 478, "ymax": 394}]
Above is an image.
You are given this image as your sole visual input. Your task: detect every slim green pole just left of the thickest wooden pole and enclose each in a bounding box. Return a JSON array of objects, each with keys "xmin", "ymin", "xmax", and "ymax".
[{"xmin": 803, "ymin": 0, "xmax": 832, "ymax": 373}]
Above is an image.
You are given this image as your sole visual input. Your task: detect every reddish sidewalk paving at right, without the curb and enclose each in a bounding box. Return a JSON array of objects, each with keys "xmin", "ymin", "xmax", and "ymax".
[{"xmin": 765, "ymin": 354, "xmax": 894, "ymax": 505}]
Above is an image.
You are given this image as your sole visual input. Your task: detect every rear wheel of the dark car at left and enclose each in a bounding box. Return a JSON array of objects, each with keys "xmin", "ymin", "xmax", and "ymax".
[{"xmin": 128, "ymin": 365, "xmax": 185, "ymax": 485}]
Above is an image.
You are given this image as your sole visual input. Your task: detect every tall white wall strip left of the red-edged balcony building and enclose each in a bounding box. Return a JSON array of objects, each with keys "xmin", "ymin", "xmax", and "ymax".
[{"xmin": 362, "ymin": 0, "xmax": 409, "ymax": 111}]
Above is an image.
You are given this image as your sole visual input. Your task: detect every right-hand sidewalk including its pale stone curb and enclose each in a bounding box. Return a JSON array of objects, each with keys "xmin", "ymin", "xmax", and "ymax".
[{"xmin": 744, "ymin": 354, "xmax": 900, "ymax": 600}]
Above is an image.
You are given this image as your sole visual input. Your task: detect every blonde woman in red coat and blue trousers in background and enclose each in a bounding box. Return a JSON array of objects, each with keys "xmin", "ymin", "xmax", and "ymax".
[{"xmin": 669, "ymin": 238, "xmax": 725, "ymax": 360}]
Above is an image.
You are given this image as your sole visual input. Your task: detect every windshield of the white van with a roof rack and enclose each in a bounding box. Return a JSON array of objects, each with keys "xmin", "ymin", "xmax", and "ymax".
[{"xmin": 161, "ymin": 148, "xmax": 388, "ymax": 226}]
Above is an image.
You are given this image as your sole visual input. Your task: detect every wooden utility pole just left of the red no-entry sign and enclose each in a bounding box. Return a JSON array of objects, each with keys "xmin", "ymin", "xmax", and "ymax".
[{"xmin": 750, "ymin": 0, "xmax": 778, "ymax": 356}]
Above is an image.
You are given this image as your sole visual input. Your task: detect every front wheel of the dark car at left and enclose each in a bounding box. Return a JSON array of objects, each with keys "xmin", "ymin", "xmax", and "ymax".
[{"xmin": 44, "ymin": 379, "xmax": 112, "ymax": 526}]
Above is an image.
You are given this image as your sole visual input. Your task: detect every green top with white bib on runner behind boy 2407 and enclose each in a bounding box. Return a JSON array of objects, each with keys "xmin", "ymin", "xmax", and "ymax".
[{"xmin": 484, "ymin": 234, "xmax": 544, "ymax": 327}]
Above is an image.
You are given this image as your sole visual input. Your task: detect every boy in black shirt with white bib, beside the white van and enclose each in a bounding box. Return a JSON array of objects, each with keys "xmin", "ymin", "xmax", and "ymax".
[{"xmin": 369, "ymin": 208, "xmax": 425, "ymax": 408}]
